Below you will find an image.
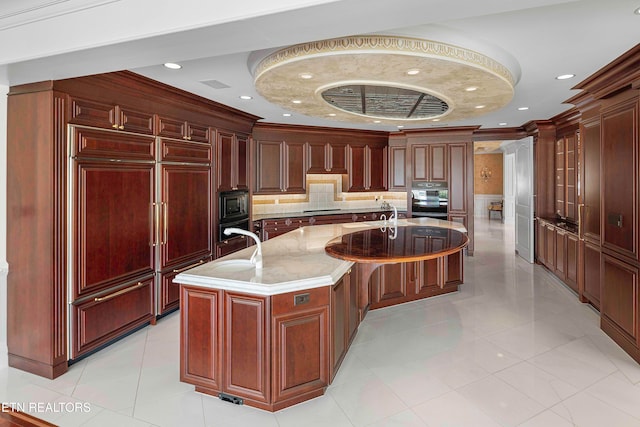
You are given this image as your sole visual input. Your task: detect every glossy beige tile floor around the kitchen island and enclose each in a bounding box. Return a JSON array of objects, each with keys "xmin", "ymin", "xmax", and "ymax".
[{"xmin": 0, "ymin": 219, "xmax": 640, "ymax": 427}]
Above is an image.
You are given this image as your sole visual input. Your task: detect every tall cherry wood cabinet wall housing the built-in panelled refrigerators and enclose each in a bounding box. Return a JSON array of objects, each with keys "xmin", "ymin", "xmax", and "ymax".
[{"xmin": 7, "ymin": 72, "xmax": 256, "ymax": 378}]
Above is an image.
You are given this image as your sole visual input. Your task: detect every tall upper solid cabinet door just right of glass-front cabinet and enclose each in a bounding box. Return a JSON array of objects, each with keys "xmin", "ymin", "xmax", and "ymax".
[{"xmin": 578, "ymin": 116, "xmax": 600, "ymax": 244}]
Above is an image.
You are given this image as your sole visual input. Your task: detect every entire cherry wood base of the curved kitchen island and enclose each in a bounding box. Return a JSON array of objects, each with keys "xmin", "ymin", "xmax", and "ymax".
[{"xmin": 180, "ymin": 251, "xmax": 463, "ymax": 412}]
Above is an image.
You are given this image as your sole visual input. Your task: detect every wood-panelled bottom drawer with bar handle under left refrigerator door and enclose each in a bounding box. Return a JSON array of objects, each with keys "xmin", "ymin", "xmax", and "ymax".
[{"xmin": 71, "ymin": 278, "xmax": 154, "ymax": 359}]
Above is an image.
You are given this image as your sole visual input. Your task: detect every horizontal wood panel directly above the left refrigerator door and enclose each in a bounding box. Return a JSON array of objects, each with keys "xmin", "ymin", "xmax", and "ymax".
[{"xmin": 72, "ymin": 127, "xmax": 155, "ymax": 161}]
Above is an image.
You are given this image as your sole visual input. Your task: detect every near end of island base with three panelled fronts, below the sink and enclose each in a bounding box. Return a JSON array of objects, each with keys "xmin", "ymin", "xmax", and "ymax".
[{"xmin": 180, "ymin": 281, "xmax": 336, "ymax": 411}]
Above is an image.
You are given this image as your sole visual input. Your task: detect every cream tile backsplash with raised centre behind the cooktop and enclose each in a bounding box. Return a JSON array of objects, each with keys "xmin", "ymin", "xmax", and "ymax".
[{"xmin": 252, "ymin": 174, "xmax": 407, "ymax": 215}]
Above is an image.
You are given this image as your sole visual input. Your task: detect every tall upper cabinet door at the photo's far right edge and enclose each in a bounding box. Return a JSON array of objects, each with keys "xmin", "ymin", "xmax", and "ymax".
[{"xmin": 602, "ymin": 101, "xmax": 639, "ymax": 260}]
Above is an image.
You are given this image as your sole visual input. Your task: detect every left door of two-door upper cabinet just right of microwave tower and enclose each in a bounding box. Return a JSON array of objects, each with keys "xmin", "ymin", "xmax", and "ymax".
[{"xmin": 255, "ymin": 141, "xmax": 283, "ymax": 194}]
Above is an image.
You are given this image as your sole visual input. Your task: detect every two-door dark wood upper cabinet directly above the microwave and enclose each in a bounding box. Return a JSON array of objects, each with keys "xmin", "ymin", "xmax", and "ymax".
[{"xmin": 215, "ymin": 130, "xmax": 250, "ymax": 192}]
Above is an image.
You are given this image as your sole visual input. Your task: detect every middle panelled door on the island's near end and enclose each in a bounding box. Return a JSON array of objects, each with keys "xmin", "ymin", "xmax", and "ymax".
[{"xmin": 223, "ymin": 292, "xmax": 271, "ymax": 403}]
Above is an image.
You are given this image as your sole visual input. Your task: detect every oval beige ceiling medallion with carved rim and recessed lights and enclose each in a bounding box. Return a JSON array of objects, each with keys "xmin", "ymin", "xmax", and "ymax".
[{"xmin": 254, "ymin": 35, "xmax": 515, "ymax": 125}]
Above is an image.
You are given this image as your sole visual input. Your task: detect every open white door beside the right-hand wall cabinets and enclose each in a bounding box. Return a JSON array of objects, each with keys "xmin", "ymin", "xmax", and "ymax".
[{"xmin": 515, "ymin": 137, "xmax": 534, "ymax": 262}]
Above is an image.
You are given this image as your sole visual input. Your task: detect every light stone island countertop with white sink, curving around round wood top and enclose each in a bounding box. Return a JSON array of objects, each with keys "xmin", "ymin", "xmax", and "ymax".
[{"xmin": 174, "ymin": 218, "xmax": 467, "ymax": 295}]
